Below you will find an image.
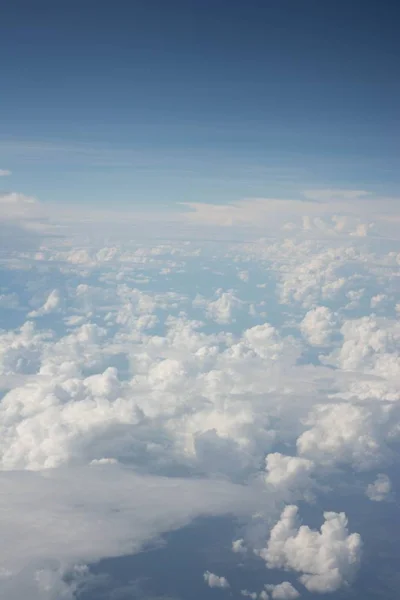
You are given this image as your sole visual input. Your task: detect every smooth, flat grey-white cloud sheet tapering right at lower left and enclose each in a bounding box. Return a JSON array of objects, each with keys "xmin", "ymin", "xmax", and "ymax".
[{"xmin": 0, "ymin": 465, "xmax": 257, "ymax": 600}]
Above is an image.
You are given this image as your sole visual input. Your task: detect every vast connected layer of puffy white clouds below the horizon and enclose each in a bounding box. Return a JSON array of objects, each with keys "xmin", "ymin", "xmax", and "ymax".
[{"xmin": 0, "ymin": 189, "xmax": 400, "ymax": 600}]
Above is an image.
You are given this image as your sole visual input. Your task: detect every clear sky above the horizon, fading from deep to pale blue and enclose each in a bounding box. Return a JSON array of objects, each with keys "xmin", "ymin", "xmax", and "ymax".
[{"xmin": 0, "ymin": 0, "xmax": 400, "ymax": 205}]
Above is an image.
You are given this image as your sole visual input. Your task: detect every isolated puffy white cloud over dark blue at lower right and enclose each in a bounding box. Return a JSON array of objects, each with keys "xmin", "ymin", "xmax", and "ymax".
[{"xmin": 257, "ymin": 505, "xmax": 361, "ymax": 597}]
